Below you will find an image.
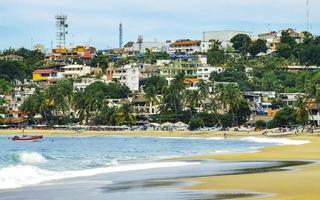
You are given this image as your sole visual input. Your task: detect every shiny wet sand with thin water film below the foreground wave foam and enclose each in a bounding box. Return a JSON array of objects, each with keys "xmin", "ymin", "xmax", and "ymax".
[{"xmin": 0, "ymin": 160, "xmax": 309, "ymax": 200}]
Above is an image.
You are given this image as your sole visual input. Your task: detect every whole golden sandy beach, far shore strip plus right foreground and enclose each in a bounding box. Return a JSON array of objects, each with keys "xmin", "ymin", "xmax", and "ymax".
[{"xmin": 0, "ymin": 130, "xmax": 320, "ymax": 200}]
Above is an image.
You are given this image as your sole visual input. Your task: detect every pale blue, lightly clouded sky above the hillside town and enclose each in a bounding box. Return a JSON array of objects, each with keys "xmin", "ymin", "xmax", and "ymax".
[{"xmin": 0, "ymin": 0, "xmax": 320, "ymax": 50}]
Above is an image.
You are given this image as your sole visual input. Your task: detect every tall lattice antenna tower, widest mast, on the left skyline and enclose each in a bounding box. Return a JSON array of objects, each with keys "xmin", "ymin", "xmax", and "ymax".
[{"xmin": 56, "ymin": 15, "xmax": 68, "ymax": 49}]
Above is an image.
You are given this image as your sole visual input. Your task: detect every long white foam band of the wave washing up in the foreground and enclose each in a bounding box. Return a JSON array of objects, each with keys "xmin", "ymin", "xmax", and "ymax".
[{"xmin": 0, "ymin": 162, "xmax": 200, "ymax": 189}]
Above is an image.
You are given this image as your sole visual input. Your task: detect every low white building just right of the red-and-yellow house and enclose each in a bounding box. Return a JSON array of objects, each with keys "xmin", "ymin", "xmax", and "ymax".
[{"xmin": 60, "ymin": 65, "xmax": 91, "ymax": 78}]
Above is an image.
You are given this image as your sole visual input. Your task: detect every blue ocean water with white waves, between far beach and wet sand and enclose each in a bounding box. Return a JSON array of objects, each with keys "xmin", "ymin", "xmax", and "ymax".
[{"xmin": 0, "ymin": 136, "xmax": 306, "ymax": 190}]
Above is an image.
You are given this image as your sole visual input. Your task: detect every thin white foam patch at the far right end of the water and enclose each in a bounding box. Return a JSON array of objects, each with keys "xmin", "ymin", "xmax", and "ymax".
[{"xmin": 240, "ymin": 137, "xmax": 310, "ymax": 145}]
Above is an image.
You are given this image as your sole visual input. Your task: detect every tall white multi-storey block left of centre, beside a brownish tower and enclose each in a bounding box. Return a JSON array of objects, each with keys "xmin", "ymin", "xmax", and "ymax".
[{"xmin": 112, "ymin": 65, "xmax": 140, "ymax": 91}]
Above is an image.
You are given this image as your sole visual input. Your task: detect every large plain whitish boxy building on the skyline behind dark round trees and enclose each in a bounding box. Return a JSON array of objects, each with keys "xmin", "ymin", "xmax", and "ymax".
[{"xmin": 203, "ymin": 30, "xmax": 252, "ymax": 48}]
